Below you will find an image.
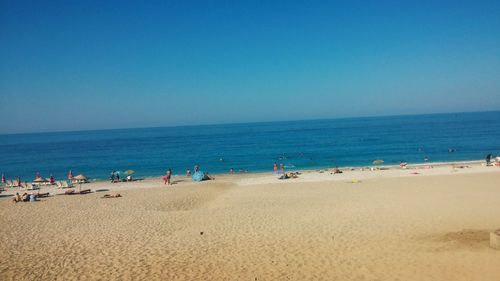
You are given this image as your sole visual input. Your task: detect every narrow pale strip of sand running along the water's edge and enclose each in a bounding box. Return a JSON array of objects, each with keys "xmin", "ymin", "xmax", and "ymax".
[{"xmin": 0, "ymin": 160, "xmax": 500, "ymax": 197}]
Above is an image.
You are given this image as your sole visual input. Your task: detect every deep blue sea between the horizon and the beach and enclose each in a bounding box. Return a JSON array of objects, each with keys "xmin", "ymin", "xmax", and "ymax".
[{"xmin": 0, "ymin": 112, "xmax": 500, "ymax": 180}]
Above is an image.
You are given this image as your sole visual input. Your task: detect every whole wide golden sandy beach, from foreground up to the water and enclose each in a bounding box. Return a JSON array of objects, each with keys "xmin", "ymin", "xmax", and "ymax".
[{"xmin": 0, "ymin": 163, "xmax": 500, "ymax": 280}]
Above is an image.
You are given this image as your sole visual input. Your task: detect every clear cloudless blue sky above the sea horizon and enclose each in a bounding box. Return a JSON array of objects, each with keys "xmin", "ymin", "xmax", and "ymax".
[{"xmin": 0, "ymin": 0, "xmax": 500, "ymax": 133}]
